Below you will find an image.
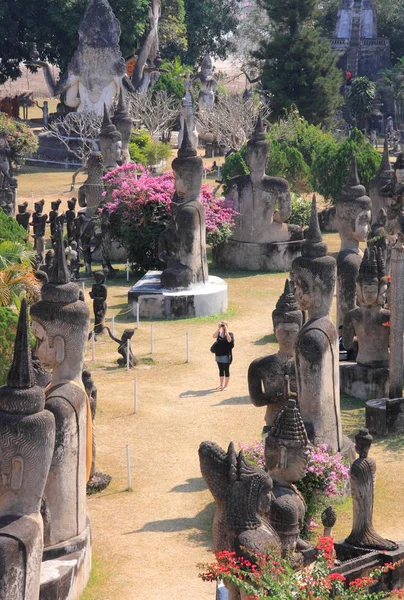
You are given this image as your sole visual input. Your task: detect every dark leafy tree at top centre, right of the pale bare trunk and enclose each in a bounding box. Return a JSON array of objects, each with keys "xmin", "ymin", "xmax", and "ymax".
[{"xmin": 182, "ymin": 0, "xmax": 240, "ymax": 66}]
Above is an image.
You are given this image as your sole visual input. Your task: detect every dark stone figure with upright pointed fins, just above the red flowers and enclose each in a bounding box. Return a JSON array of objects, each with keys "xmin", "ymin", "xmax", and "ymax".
[{"xmin": 199, "ymin": 442, "xmax": 281, "ymax": 600}]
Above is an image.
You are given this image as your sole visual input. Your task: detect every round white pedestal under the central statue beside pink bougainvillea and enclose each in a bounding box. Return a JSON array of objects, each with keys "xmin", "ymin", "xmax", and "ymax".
[{"xmin": 128, "ymin": 271, "xmax": 227, "ymax": 319}]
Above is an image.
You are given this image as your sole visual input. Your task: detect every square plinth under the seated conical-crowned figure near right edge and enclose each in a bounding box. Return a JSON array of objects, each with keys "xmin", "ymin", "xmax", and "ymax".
[{"xmin": 339, "ymin": 362, "xmax": 389, "ymax": 400}]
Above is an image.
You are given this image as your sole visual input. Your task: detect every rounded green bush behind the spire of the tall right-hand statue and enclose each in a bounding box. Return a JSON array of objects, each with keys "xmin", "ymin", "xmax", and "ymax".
[{"xmin": 311, "ymin": 129, "xmax": 381, "ymax": 202}]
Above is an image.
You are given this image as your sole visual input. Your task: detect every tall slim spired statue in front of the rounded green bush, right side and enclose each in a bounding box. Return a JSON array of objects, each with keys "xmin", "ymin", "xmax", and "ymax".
[{"xmin": 335, "ymin": 154, "xmax": 372, "ymax": 326}]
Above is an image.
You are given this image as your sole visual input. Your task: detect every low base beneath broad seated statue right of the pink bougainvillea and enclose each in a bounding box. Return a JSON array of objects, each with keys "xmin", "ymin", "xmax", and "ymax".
[{"xmin": 212, "ymin": 240, "xmax": 303, "ymax": 271}]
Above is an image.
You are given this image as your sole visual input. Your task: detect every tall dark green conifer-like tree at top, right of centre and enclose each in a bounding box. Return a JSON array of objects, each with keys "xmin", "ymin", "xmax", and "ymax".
[{"xmin": 254, "ymin": 0, "xmax": 343, "ymax": 125}]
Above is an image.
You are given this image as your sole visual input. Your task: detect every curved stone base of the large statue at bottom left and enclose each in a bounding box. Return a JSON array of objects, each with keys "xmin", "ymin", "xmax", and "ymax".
[{"xmin": 39, "ymin": 521, "xmax": 91, "ymax": 600}]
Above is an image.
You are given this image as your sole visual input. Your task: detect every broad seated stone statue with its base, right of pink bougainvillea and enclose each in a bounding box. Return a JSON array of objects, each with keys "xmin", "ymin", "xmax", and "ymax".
[{"xmin": 214, "ymin": 117, "xmax": 303, "ymax": 271}]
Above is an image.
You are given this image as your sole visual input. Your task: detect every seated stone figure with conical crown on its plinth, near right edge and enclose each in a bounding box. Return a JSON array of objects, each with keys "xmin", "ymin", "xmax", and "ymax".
[{"xmin": 340, "ymin": 247, "xmax": 390, "ymax": 400}]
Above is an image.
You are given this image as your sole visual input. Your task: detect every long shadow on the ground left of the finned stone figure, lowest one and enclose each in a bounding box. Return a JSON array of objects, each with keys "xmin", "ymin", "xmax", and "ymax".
[{"xmin": 123, "ymin": 502, "xmax": 215, "ymax": 546}]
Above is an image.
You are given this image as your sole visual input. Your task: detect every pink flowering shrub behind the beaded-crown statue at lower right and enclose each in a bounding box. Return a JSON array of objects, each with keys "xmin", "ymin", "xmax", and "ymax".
[{"xmin": 240, "ymin": 442, "xmax": 349, "ymax": 535}]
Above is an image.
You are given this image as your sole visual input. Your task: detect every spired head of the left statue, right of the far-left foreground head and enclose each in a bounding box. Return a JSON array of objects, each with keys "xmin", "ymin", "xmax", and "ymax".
[{"xmin": 31, "ymin": 229, "xmax": 89, "ymax": 383}]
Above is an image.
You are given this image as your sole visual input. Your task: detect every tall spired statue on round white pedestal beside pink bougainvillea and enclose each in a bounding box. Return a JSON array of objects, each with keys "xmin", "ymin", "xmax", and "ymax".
[{"xmin": 160, "ymin": 123, "xmax": 208, "ymax": 289}]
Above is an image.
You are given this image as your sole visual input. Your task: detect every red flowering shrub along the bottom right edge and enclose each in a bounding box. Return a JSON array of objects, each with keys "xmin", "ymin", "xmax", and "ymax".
[{"xmin": 198, "ymin": 537, "xmax": 404, "ymax": 600}]
